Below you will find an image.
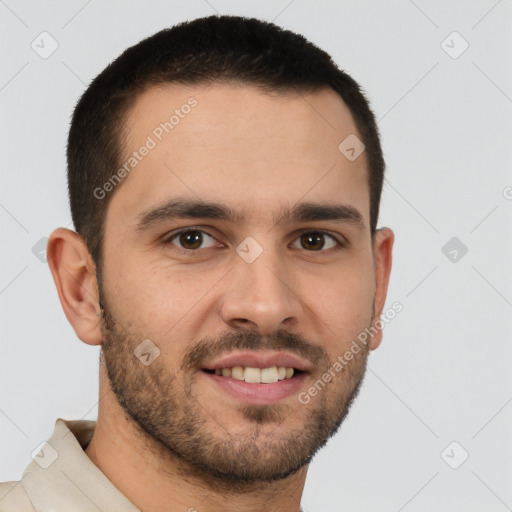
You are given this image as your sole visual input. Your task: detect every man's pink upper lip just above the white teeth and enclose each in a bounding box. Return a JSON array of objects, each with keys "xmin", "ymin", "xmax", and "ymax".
[{"xmin": 203, "ymin": 350, "xmax": 312, "ymax": 372}]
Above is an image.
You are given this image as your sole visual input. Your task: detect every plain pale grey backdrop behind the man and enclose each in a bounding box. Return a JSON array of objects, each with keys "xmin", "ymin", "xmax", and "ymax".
[{"xmin": 0, "ymin": 0, "xmax": 512, "ymax": 512}]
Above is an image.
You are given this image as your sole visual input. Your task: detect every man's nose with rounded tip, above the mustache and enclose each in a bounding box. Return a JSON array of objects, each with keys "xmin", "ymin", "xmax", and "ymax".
[{"xmin": 221, "ymin": 249, "xmax": 303, "ymax": 335}]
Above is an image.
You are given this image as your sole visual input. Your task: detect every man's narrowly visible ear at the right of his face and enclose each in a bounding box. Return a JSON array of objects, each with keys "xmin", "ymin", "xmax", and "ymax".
[{"xmin": 369, "ymin": 228, "xmax": 395, "ymax": 350}]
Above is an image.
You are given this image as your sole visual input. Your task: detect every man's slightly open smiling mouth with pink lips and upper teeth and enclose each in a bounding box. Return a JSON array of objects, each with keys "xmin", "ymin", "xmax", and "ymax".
[{"xmin": 202, "ymin": 352, "xmax": 310, "ymax": 405}]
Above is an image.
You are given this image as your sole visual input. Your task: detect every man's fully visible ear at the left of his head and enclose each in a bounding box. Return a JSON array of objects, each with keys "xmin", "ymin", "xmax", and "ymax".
[{"xmin": 46, "ymin": 228, "xmax": 102, "ymax": 345}]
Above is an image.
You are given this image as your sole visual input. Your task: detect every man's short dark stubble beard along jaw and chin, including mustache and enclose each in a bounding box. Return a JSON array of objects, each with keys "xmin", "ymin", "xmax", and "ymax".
[{"xmin": 100, "ymin": 284, "xmax": 368, "ymax": 492}]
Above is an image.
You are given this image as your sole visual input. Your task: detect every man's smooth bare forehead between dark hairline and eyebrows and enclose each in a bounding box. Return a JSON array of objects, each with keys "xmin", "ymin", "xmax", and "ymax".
[{"xmin": 109, "ymin": 84, "xmax": 369, "ymax": 228}]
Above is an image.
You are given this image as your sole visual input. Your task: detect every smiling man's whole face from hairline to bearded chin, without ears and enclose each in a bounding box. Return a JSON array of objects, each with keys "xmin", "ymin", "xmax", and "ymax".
[{"xmin": 100, "ymin": 84, "xmax": 375, "ymax": 486}]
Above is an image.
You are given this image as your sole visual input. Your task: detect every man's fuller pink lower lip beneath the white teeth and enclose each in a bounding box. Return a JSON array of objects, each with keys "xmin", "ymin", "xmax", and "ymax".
[{"xmin": 201, "ymin": 371, "xmax": 307, "ymax": 405}]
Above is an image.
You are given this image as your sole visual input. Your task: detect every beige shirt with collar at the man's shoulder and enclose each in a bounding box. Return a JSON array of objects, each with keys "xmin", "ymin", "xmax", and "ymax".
[{"xmin": 0, "ymin": 418, "xmax": 140, "ymax": 512}]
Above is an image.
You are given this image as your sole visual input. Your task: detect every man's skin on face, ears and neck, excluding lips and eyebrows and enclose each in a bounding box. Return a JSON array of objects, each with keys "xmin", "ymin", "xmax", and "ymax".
[{"xmin": 47, "ymin": 84, "xmax": 394, "ymax": 512}]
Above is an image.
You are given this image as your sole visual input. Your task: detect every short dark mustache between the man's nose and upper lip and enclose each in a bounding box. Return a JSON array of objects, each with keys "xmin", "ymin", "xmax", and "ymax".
[{"xmin": 181, "ymin": 329, "xmax": 331, "ymax": 371}]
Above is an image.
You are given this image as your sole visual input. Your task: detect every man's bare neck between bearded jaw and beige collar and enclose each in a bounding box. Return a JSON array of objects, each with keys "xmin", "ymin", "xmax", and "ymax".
[{"xmin": 85, "ymin": 372, "xmax": 307, "ymax": 512}]
